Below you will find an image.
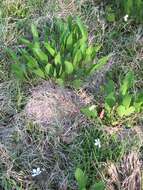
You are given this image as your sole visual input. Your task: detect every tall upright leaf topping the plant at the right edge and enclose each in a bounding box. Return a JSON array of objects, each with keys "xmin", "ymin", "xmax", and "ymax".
[{"xmin": 120, "ymin": 71, "xmax": 134, "ymax": 96}]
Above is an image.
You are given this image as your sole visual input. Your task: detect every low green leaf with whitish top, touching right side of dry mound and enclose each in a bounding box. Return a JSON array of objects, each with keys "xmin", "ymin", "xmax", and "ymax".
[{"xmin": 81, "ymin": 105, "xmax": 98, "ymax": 119}]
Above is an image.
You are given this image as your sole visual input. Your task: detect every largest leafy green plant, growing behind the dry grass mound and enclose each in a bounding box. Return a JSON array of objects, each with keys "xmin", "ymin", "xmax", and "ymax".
[{"xmin": 8, "ymin": 17, "xmax": 110, "ymax": 84}]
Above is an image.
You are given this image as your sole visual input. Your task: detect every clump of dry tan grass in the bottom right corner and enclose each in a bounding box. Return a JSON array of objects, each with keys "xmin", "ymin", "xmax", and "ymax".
[{"xmin": 108, "ymin": 152, "xmax": 141, "ymax": 190}]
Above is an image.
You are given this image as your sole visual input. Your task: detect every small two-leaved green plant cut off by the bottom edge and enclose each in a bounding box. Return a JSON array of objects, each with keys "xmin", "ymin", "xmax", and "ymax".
[{"xmin": 75, "ymin": 168, "xmax": 105, "ymax": 190}]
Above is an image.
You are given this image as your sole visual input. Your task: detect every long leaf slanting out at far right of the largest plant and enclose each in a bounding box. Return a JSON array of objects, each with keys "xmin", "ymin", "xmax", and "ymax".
[{"xmin": 88, "ymin": 55, "xmax": 110, "ymax": 74}]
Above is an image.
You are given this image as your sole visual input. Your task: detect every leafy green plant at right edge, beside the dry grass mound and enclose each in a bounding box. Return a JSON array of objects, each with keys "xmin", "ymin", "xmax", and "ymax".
[{"xmin": 81, "ymin": 71, "xmax": 143, "ymax": 125}]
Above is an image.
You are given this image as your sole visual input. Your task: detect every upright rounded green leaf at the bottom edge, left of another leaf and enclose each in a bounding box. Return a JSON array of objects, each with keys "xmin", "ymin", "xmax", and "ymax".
[{"xmin": 75, "ymin": 168, "xmax": 87, "ymax": 190}]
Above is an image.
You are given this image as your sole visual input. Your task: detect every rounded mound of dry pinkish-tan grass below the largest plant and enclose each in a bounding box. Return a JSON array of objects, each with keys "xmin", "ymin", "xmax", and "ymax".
[{"xmin": 25, "ymin": 82, "xmax": 89, "ymax": 130}]
